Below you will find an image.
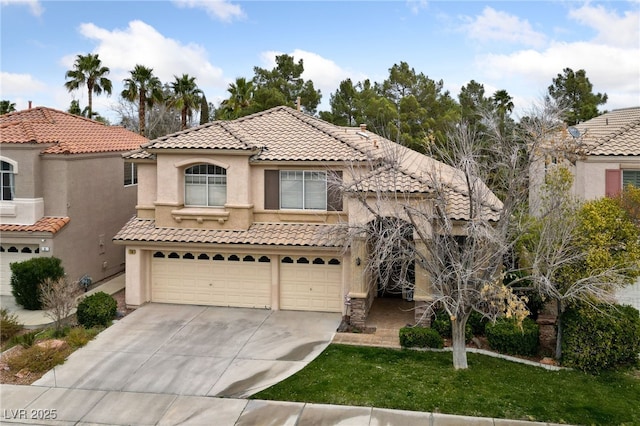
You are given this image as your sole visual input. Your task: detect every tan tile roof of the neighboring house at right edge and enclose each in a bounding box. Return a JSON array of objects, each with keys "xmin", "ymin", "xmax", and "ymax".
[{"xmin": 575, "ymin": 107, "xmax": 640, "ymax": 155}]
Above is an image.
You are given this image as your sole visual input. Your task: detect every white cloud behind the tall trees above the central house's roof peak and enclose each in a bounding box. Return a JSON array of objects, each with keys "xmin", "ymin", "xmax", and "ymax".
[{"xmin": 260, "ymin": 49, "xmax": 367, "ymax": 100}]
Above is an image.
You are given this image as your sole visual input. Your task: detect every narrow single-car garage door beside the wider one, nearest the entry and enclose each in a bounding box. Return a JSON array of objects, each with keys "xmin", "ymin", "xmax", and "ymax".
[{"xmin": 280, "ymin": 257, "xmax": 342, "ymax": 312}]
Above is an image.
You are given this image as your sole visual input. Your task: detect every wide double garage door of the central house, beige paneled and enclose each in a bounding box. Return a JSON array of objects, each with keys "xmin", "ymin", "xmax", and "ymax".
[{"xmin": 151, "ymin": 251, "xmax": 271, "ymax": 308}]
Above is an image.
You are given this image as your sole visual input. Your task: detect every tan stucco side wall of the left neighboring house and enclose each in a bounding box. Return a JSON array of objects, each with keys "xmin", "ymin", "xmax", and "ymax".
[{"xmin": 42, "ymin": 152, "xmax": 137, "ymax": 282}]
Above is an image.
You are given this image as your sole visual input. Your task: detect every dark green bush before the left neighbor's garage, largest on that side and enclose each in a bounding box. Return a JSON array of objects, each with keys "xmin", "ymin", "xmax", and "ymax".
[{"xmin": 11, "ymin": 257, "xmax": 64, "ymax": 310}]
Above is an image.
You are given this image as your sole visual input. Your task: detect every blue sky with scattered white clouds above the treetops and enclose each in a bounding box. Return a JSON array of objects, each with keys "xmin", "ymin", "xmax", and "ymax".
[{"xmin": 0, "ymin": 0, "xmax": 640, "ymax": 124}]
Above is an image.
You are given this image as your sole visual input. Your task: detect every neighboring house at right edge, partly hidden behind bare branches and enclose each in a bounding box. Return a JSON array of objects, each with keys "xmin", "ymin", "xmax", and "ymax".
[{"xmin": 531, "ymin": 107, "xmax": 640, "ymax": 309}]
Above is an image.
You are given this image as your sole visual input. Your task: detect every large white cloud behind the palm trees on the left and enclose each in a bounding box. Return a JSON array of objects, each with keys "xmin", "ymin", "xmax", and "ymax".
[{"xmin": 62, "ymin": 20, "xmax": 226, "ymax": 93}]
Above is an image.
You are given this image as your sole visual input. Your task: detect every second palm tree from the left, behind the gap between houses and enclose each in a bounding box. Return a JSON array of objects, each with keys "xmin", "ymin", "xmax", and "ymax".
[{"xmin": 121, "ymin": 65, "xmax": 164, "ymax": 136}]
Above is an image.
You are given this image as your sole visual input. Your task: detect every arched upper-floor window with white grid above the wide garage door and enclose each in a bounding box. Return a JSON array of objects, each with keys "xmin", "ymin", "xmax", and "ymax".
[{"xmin": 184, "ymin": 164, "xmax": 227, "ymax": 207}]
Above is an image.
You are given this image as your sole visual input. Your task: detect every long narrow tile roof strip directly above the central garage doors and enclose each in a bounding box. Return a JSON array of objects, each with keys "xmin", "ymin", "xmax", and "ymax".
[{"xmin": 113, "ymin": 217, "xmax": 342, "ymax": 248}]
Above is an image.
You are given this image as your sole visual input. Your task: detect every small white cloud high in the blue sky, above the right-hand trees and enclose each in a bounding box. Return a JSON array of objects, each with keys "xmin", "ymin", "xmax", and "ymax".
[{"xmin": 461, "ymin": 7, "xmax": 546, "ymax": 47}]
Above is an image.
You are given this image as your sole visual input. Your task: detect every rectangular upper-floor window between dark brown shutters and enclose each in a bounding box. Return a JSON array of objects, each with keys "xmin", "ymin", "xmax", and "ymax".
[{"xmin": 280, "ymin": 170, "xmax": 327, "ymax": 210}]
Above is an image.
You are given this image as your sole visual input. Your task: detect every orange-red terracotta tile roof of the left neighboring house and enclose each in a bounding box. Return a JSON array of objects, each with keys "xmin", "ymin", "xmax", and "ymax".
[{"xmin": 0, "ymin": 107, "xmax": 148, "ymax": 154}]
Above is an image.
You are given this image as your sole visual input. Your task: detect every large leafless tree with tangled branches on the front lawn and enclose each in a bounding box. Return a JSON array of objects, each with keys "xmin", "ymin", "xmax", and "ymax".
[{"xmin": 338, "ymin": 98, "xmax": 562, "ymax": 369}]
